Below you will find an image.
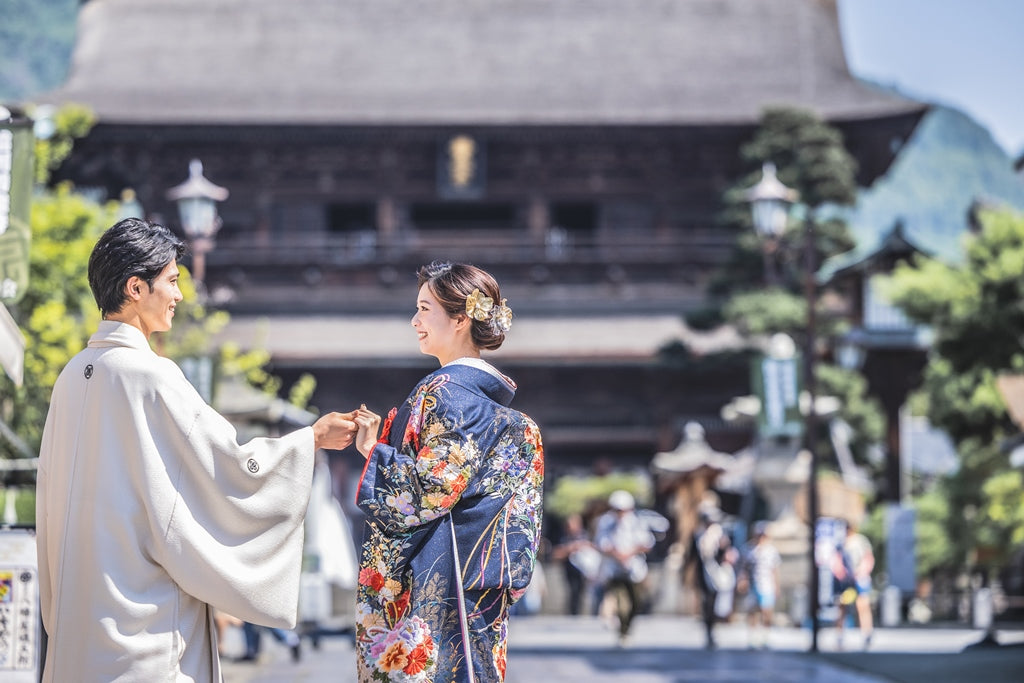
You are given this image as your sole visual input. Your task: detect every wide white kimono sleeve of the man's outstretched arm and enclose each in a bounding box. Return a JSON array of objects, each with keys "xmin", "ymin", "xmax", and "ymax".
[{"xmin": 142, "ymin": 368, "xmax": 314, "ymax": 628}]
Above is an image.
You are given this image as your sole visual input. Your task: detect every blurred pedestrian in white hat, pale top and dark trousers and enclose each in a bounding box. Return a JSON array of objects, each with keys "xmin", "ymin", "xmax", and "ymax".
[{"xmin": 594, "ymin": 489, "xmax": 654, "ymax": 645}]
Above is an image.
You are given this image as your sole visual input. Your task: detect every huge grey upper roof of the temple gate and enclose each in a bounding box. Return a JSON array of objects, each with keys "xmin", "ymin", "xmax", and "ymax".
[{"xmin": 41, "ymin": 0, "xmax": 924, "ymax": 125}]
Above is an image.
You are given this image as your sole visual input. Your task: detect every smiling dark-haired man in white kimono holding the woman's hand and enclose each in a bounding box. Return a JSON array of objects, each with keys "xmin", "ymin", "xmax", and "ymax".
[{"xmin": 36, "ymin": 218, "xmax": 356, "ymax": 683}]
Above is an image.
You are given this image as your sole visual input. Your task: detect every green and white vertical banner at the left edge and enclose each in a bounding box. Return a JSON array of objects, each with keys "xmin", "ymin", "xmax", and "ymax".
[{"xmin": 0, "ymin": 113, "xmax": 36, "ymax": 305}]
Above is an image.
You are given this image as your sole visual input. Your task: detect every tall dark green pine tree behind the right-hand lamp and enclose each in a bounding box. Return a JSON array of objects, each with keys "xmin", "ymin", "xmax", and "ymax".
[{"xmin": 705, "ymin": 108, "xmax": 884, "ymax": 475}]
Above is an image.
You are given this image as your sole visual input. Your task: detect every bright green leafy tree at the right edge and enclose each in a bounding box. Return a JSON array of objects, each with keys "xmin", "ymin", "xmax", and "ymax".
[{"xmin": 886, "ymin": 205, "xmax": 1024, "ymax": 568}]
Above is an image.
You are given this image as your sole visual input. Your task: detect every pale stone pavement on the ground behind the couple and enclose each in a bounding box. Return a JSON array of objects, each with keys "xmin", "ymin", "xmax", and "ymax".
[{"xmin": 224, "ymin": 615, "xmax": 1024, "ymax": 683}]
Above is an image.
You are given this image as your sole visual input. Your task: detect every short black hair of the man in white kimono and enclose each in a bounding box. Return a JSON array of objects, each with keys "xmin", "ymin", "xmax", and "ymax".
[{"xmin": 89, "ymin": 218, "xmax": 185, "ymax": 315}]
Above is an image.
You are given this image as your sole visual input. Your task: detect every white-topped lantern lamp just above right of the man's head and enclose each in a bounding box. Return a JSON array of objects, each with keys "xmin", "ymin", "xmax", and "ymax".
[{"xmin": 167, "ymin": 159, "xmax": 228, "ymax": 299}]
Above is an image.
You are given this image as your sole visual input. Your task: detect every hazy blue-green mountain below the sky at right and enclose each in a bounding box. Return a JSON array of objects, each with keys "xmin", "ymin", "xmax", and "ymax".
[{"xmin": 846, "ymin": 105, "xmax": 1024, "ymax": 261}]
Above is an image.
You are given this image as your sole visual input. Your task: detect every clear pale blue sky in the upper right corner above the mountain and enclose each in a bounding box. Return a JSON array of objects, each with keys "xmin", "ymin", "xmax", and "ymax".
[{"xmin": 839, "ymin": 0, "xmax": 1024, "ymax": 158}]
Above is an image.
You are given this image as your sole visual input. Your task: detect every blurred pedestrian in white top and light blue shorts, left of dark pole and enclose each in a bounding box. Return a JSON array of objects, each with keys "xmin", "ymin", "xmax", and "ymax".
[{"xmin": 737, "ymin": 521, "xmax": 782, "ymax": 647}]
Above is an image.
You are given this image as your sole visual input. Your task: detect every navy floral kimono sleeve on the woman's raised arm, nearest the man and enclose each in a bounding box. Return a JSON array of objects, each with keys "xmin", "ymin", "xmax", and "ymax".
[{"xmin": 356, "ymin": 391, "xmax": 483, "ymax": 530}]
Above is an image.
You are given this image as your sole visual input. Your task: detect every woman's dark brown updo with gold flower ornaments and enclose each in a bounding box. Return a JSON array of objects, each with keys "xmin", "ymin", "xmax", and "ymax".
[{"xmin": 416, "ymin": 261, "xmax": 512, "ymax": 351}]
